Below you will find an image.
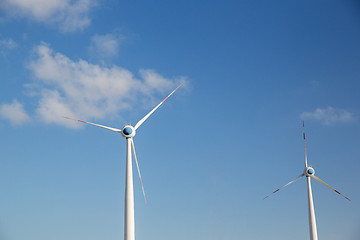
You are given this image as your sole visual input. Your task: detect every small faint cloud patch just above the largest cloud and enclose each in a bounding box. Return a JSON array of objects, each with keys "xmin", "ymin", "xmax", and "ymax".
[{"xmin": 90, "ymin": 34, "xmax": 121, "ymax": 58}]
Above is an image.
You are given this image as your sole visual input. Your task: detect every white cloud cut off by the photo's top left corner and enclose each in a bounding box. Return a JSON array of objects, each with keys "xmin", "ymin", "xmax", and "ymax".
[{"xmin": 0, "ymin": 0, "xmax": 95, "ymax": 32}]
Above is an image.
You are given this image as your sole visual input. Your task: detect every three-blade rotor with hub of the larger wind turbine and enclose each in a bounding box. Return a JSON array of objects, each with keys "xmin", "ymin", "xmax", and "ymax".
[{"xmin": 64, "ymin": 84, "xmax": 181, "ymax": 203}]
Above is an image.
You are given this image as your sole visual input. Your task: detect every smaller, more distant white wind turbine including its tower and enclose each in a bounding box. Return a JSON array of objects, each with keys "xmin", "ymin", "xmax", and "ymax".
[{"xmin": 264, "ymin": 121, "xmax": 351, "ymax": 240}]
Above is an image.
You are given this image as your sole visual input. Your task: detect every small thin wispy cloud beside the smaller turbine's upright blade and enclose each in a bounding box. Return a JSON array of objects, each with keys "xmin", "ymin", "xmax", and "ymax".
[{"xmin": 301, "ymin": 106, "xmax": 355, "ymax": 125}]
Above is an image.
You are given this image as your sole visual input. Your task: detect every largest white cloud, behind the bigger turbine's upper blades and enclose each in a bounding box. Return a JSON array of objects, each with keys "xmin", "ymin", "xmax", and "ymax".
[{"xmin": 28, "ymin": 43, "xmax": 186, "ymax": 127}]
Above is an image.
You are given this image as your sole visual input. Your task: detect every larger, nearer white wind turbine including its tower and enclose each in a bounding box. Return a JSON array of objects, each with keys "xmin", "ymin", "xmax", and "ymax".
[{"xmin": 64, "ymin": 84, "xmax": 181, "ymax": 240}]
